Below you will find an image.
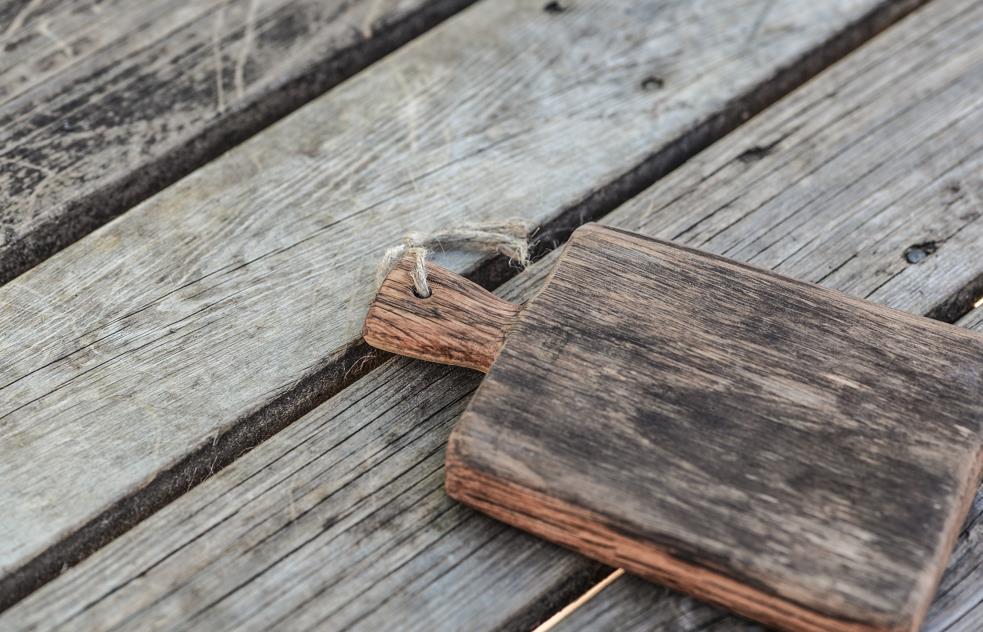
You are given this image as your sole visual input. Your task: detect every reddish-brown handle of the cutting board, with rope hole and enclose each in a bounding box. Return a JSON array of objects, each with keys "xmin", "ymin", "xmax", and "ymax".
[{"xmin": 362, "ymin": 256, "xmax": 520, "ymax": 373}]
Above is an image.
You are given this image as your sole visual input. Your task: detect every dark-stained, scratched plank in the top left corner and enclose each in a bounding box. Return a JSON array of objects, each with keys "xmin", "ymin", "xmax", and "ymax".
[{"xmin": 0, "ymin": 0, "xmax": 470, "ymax": 283}]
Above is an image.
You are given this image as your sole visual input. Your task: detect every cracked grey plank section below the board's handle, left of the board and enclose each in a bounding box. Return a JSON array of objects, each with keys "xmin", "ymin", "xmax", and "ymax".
[{"xmin": 0, "ymin": 266, "xmax": 597, "ymax": 630}]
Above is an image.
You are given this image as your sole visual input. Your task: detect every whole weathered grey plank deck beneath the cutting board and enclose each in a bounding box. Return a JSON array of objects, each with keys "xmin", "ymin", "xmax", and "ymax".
[{"xmin": 0, "ymin": 0, "xmax": 983, "ymax": 631}]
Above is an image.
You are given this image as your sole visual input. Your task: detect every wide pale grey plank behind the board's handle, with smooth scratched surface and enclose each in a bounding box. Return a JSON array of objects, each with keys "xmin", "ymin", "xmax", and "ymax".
[{"xmin": 0, "ymin": 0, "xmax": 917, "ymax": 601}]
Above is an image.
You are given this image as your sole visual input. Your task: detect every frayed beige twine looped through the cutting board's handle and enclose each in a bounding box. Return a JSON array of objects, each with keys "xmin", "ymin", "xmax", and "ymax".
[{"xmin": 376, "ymin": 219, "xmax": 534, "ymax": 298}]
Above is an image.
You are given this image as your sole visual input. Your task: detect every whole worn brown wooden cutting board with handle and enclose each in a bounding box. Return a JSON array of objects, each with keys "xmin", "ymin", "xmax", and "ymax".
[{"xmin": 365, "ymin": 225, "xmax": 983, "ymax": 631}]
